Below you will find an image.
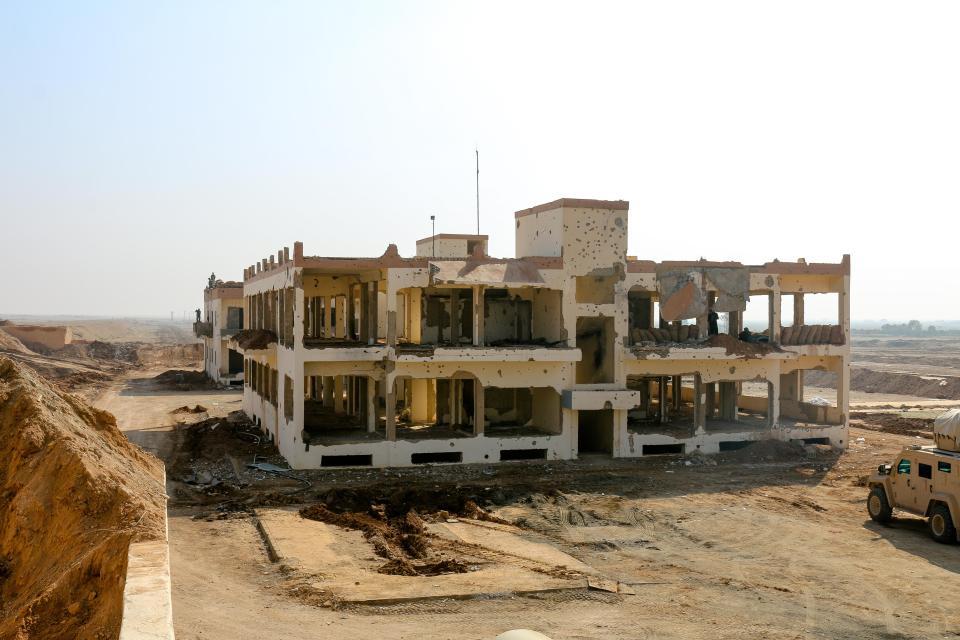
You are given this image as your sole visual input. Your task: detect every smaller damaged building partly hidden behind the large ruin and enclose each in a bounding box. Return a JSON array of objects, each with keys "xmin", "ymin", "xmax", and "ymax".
[{"xmin": 193, "ymin": 280, "xmax": 244, "ymax": 387}]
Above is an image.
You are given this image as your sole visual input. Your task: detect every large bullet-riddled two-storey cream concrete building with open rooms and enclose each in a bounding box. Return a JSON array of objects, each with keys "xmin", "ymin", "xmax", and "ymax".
[{"xmin": 231, "ymin": 199, "xmax": 850, "ymax": 468}]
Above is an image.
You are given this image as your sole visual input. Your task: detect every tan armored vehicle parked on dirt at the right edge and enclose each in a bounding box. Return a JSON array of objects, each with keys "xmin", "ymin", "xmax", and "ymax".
[{"xmin": 867, "ymin": 409, "xmax": 960, "ymax": 542}]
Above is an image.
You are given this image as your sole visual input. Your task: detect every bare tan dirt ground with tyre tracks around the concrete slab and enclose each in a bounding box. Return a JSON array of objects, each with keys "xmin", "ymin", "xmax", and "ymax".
[{"xmin": 98, "ymin": 372, "xmax": 960, "ymax": 640}]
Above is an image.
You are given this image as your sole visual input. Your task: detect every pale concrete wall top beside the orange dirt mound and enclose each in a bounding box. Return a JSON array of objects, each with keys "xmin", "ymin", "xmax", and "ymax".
[{"xmin": 120, "ymin": 470, "xmax": 174, "ymax": 640}]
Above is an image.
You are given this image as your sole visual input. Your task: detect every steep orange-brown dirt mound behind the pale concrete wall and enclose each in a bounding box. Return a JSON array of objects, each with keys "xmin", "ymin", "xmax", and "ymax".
[{"xmin": 0, "ymin": 358, "xmax": 165, "ymax": 640}]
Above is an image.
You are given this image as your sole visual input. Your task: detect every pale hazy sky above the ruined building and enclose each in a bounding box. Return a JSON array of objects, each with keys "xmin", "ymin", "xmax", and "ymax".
[{"xmin": 0, "ymin": 0, "xmax": 960, "ymax": 320}]
